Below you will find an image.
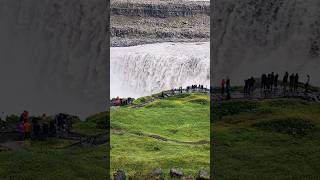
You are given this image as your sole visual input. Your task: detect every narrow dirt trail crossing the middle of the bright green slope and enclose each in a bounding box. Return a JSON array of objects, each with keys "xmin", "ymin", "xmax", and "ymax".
[{"xmin": 112, "ymin": 129, "xmax": 210, "ymax": 145}]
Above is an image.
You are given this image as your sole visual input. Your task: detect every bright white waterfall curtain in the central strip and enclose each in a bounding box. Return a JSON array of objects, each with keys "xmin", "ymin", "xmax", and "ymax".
[{"xmin": 110, "ymin": 42, "xmax": 210, "ymax": 97}]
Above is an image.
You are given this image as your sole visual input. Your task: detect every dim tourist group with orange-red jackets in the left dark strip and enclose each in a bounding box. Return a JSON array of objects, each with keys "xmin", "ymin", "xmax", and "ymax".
[{"xmin": 18, "ymin": 111, "xmax": 72, "ymax": 140}]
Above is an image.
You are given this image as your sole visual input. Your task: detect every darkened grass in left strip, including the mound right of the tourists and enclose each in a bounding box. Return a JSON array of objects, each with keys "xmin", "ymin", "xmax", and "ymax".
[{"xmin": 0, "ymin": 113, "xmax": 109, "ymax": 180}]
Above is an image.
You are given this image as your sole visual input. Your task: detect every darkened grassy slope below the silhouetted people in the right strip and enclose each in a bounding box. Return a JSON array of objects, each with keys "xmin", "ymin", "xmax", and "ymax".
[{"xmin": 211, "ymin": 99, "xmax": 320, "ymax": 179}]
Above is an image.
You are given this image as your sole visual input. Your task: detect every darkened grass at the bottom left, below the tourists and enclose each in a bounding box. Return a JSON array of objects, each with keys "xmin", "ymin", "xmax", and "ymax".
[{"xmin": 0, "ymin": 141, "xmax": 108, "ymax": 180}]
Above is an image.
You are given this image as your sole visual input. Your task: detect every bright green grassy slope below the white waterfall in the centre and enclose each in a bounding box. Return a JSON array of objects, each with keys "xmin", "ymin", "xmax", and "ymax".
[{"xmin": 111, "ymin": 94, "xmax": 210, "ymax": 178}]
